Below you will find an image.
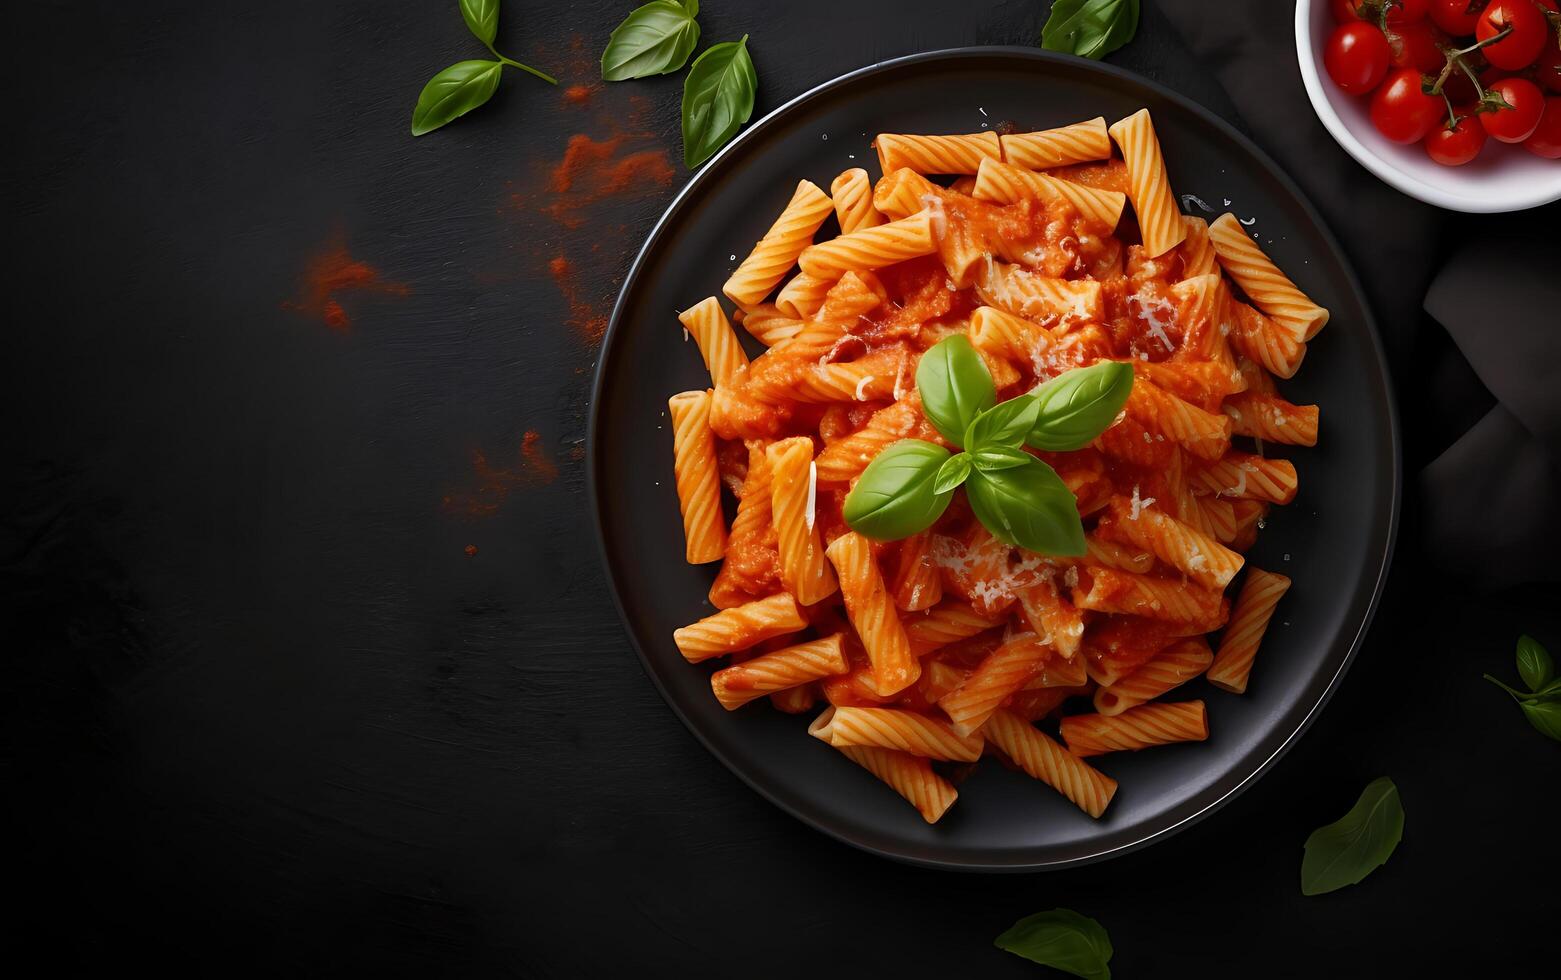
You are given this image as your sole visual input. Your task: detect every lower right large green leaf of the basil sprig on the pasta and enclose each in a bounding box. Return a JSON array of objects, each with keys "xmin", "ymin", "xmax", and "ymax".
[{"xmin": 965, "ymin": 456, "xmax": 1085, "ymax": 556}]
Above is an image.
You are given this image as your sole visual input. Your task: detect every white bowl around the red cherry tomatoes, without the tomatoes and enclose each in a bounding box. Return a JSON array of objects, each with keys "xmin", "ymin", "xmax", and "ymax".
[{"xmin": 1296, "ymin": 0, "xmax": 1561, "ymax": 212}]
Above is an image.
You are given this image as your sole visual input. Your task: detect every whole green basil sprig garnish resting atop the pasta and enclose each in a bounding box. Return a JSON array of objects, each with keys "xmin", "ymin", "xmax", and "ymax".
[{"xmin": 845, "ymin": 334, "xmax": 1133, "ymax": 556}]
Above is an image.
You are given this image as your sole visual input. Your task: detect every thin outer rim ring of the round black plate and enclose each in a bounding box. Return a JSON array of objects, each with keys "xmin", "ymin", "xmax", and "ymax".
[{"xmin": 585, "ymin": 45, "xmax": 1403, "ymax": 872}]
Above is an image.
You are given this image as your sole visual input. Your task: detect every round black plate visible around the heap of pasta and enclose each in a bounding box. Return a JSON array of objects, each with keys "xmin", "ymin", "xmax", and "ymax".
[{"xmin": 588, "ymin": 48, "xmax": 1399, "ymax": 871}]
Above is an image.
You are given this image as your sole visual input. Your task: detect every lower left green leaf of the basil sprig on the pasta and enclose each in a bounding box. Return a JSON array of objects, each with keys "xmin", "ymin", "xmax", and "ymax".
[{"xmin": 843, "ymin": 439, "xmax": 954, "ymax": 541}]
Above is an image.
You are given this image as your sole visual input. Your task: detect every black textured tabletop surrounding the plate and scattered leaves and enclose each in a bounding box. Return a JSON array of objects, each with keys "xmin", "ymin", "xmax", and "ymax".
[{"xmin": 0, "ymin": 0, "xmax": 1561, "ymax": 977}]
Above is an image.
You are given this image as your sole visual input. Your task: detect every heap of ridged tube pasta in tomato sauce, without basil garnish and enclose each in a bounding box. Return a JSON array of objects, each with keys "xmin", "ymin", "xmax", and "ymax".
[{"xmin": 668, "ymin": 111, "xmax": 1327, "ymax": 824}]
